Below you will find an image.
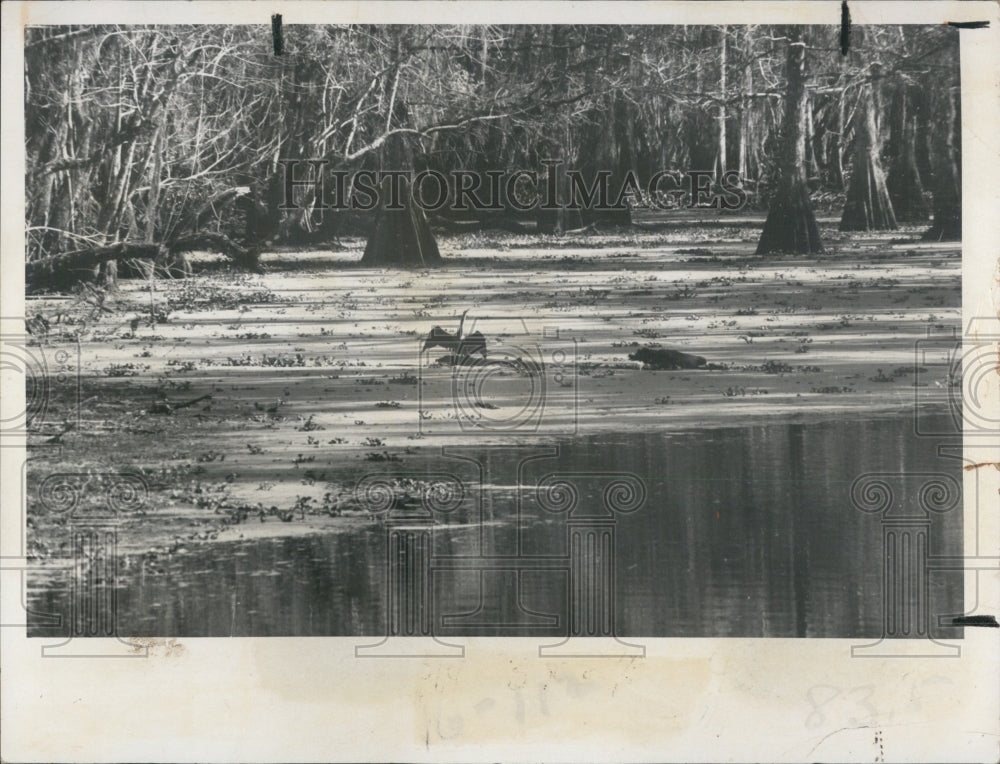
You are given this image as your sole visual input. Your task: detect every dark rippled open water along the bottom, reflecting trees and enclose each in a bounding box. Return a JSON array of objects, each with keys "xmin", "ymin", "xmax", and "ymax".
[{"xmin": 29, "ymin": 416, "xmax": 963, "ymax": 638}]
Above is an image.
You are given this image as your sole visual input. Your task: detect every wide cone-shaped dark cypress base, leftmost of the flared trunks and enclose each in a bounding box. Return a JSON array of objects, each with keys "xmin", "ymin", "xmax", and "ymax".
[{"xmin": 361, "ymin": 178, "xmax": 441, "ymax": 268}]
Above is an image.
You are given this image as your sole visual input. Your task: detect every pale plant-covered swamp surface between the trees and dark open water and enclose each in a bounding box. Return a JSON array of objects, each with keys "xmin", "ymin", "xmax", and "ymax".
[{"xmin": 27, "ymin": 228, "xmax": 961, "ymax": 567}]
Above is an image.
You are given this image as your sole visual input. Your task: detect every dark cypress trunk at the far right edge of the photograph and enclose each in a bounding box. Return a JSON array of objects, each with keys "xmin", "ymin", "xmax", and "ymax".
[{"xmin": 923, "ymin": 87, "xmax": 962, "ymax": 241}]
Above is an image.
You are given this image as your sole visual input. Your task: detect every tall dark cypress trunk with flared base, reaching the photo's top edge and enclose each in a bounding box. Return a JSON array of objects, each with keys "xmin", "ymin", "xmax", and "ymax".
[{"xmin": 757, "ymin": 27, "xmax": 823, "ymax": 255}]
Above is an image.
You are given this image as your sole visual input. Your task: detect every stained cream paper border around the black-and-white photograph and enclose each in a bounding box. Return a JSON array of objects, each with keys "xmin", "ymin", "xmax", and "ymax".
[{"xmin": 0, "ymin": 0, "xmax": 1000, "ymax": 762}]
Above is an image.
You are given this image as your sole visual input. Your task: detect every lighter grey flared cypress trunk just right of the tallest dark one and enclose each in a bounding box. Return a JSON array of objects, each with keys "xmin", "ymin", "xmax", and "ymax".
[{"xmin": 840, "ymin": 74, "xmax": 897, "ymax": 231}]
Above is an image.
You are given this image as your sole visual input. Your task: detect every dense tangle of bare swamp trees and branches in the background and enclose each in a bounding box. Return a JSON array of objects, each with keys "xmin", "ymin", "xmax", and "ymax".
[{"xmin": 25, "ymin": 25, "xmax": 961, "ymax": 285}]
